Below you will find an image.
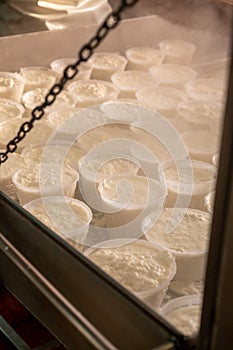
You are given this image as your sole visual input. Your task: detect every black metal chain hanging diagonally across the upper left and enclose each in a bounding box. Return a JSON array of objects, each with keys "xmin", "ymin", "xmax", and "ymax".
[{"xmin": 0, "ymin": 0, "xmax": 139, "ymax": 165}]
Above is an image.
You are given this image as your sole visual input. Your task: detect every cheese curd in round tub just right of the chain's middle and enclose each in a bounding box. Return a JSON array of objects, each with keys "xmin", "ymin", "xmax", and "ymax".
[{"xmin": 68, "ymin": 79, "xmax": 119, "ymax": 107}]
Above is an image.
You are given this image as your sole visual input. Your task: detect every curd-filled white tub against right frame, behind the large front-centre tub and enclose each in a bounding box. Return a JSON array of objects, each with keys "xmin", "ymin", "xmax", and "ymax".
[{"xmin": 143, "ymin": 208, "xmax": 211, "ymax": 281}]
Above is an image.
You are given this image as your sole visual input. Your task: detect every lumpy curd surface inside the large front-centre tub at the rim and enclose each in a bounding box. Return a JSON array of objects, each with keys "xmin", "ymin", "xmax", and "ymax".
[{"xmin": 87, "ymin": 241, "xmax": 174, "ymax": 293}]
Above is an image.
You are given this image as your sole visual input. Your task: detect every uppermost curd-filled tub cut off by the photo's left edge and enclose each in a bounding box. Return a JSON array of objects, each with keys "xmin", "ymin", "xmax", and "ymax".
[{"xmin": 0, "ymin": 72, "xmax": 25, "ymax": 102}]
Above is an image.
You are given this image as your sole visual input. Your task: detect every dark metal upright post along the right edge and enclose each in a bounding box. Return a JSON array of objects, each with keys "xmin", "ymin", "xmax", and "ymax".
[{"xmin": 199, "ymin": 19, "xmax": 233, "ymax": 350}]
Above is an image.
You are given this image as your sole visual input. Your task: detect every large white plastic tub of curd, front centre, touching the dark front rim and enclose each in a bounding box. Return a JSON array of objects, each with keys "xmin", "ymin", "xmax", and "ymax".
[{"xmin": 84, "ymin": 239, "xmax": 176, "ymax": 308}]
